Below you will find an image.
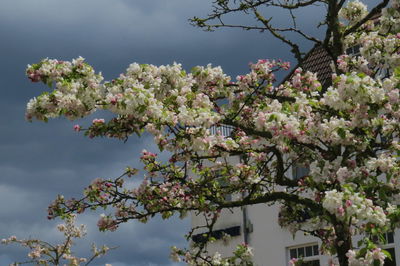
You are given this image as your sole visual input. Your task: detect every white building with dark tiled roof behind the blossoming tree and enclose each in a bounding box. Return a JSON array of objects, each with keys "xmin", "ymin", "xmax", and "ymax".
[{"xmin": 192, "ymin": 46, "xmax": 400, "ymax": 266}]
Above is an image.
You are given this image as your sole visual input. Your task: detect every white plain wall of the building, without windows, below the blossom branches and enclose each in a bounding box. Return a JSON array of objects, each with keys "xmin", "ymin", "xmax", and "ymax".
[{"xmin": 192, "ymin": 201, "xmax": 400, "ymax": 266}]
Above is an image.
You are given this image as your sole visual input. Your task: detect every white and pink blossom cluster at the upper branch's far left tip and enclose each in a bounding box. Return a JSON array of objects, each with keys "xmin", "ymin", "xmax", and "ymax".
[{"xmin": 26, "ymin": 57, "xmax": 103, "ymax": 120}]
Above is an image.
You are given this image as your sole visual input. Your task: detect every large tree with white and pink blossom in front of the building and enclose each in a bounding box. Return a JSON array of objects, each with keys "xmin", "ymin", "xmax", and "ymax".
[{"xmin": 17, "ymin": 0, "xmax": 400, "ymax": 266}]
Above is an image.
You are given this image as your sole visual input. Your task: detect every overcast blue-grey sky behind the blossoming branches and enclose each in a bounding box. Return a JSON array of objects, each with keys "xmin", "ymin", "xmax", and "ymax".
[{"xmin": 0, "ymin": 0, "xmax": 324, "ymax": 266}]
